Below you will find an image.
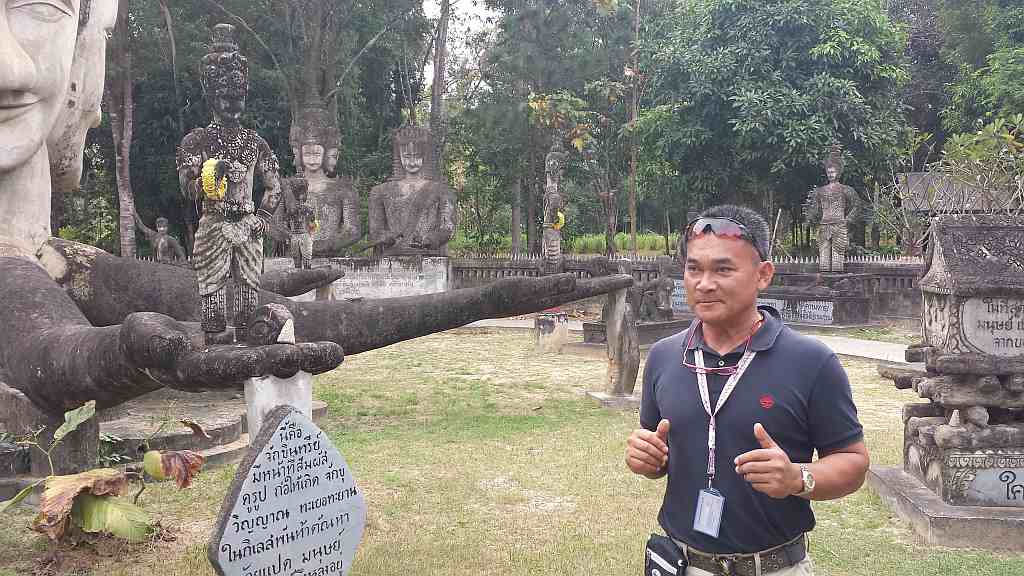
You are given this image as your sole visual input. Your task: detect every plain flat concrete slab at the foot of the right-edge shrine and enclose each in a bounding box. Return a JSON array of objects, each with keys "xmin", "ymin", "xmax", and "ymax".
[{"xmin": 867, "ymin": 466, "xmax": 1024, "ymax": 552}]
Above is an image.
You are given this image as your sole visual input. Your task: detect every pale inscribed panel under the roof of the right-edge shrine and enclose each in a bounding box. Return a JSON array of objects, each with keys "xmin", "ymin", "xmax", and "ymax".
[{"xmin": 961, "ymin": 298, "xmax": 1024, "ymax": 356}]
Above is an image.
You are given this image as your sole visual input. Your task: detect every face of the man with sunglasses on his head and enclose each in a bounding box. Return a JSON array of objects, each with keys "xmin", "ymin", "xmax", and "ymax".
[{"xmin": 683, "ymin": 234, "xmax": 775, "ymax": 326}]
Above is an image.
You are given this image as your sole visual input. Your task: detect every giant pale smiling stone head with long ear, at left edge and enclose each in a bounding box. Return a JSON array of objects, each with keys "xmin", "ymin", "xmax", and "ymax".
[{"xmin": 0, "ymin": 0, "xmax": 117, "ymax": 177}]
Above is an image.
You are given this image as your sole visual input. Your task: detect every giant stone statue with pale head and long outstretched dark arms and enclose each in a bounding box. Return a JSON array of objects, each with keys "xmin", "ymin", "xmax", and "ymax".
[{"xmin": 0, "ymin": 0, "xmax": 631, "ymax": 421}]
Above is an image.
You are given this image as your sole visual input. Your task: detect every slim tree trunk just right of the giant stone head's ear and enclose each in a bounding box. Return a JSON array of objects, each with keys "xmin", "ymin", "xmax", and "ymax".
[{"xmin": 111, "ymin": 2, "xmax": 135, "ymax": 257}]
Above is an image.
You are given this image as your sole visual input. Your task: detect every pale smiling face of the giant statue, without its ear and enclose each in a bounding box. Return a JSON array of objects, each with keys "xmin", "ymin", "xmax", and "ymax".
[{"xmin": 0, "ymin": 0, "xmax": 79, "ymax": 173}]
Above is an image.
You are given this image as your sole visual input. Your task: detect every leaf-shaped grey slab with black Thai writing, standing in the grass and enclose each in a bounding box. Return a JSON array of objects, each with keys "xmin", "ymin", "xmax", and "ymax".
[{"xmin": 207, "ymin": 406, "xmax": 367, "ymax": 576}]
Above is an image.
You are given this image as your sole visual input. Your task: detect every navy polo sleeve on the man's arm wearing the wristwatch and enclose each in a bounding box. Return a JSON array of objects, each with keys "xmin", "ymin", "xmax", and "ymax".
[{"xmin": 809, "ymin": 354, "xmax": 864, "ymax": 457}]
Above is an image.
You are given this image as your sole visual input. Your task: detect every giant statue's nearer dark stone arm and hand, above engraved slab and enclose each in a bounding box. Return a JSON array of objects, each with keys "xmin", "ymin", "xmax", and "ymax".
[{"xmin": 0, "ymin": 252, "xmax": 342, "ymax": 415}]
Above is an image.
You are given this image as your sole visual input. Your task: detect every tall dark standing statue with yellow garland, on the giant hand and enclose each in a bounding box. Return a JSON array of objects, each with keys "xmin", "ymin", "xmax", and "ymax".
[{"xmin": 177, "ymin": 24, "xmax": 281, "ymax": 343}]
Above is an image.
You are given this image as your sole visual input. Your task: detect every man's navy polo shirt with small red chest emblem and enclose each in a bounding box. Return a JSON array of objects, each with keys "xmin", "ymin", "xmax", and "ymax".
[{"xmin": 640, "ymin": 306, "xmax": 863, "ymax": 553}]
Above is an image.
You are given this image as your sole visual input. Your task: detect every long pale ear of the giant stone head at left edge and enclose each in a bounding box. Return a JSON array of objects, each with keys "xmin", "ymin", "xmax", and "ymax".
[{"xmin": 46, "ymin": 0, "xmax": 118, "ymax": 192}]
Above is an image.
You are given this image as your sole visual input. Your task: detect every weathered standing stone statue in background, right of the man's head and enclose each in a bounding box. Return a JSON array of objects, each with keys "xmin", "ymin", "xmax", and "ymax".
[{"xmin": 804, "ymin": 145, "xmax": 857, "ymax": 272}]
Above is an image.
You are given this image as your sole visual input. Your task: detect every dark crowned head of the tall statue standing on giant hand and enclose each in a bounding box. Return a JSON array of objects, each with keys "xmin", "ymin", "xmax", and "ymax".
[{"xmin": 202, "ymin": 24, "xmax": 249, "ymax": 124}]
